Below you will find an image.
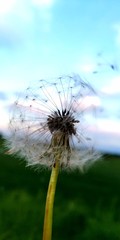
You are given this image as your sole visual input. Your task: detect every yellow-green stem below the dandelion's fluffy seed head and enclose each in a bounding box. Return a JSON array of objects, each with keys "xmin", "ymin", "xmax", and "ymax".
[{"xmin": 43, "ymin": 159, "xmax": 60, "ymax": 240}]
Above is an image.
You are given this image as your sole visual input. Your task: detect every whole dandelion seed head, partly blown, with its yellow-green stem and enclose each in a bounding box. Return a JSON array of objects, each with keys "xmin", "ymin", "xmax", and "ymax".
[{"xmin": 6, "ymin": 76, "xmax": 100, "ymax": 240}]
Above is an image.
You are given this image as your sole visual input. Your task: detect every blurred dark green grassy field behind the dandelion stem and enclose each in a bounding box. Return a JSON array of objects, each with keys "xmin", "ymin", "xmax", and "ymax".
[{"xmin": 0, "ymin": 137, "xmax": 120, "ymax": 240}]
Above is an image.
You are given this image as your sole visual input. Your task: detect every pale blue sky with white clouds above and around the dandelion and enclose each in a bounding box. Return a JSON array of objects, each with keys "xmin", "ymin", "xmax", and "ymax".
[{"xmin": 0, "ymin": 0, "xmax": 120, "ymax": 154}]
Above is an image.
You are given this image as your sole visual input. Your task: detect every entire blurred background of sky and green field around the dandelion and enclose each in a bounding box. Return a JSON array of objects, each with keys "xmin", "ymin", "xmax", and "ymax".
[{"xmin": 0, "ymin": 0, "xmax": 120, "ymax": 240}]
